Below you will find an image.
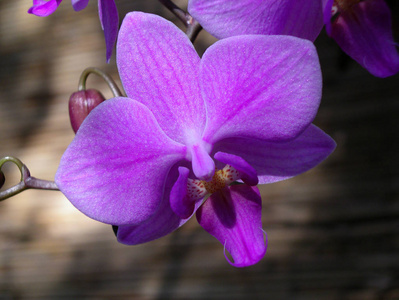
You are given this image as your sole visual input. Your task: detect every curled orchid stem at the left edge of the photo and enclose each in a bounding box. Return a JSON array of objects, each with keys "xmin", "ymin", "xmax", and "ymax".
[{"xmin": 0, "ymin": 156, "xmax": 59, "ymax": 201}]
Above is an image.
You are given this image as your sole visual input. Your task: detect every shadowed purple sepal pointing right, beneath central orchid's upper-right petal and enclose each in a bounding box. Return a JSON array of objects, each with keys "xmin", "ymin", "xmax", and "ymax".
[{"xmin": 214, "ymin": 125, "xmax": 336, "ymax": 184}]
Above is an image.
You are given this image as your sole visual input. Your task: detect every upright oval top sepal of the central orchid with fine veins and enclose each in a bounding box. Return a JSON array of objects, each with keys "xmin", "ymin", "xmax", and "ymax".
[{"xmin": 117, "ymin": 12, "xmax": 205, "ymax": 144}]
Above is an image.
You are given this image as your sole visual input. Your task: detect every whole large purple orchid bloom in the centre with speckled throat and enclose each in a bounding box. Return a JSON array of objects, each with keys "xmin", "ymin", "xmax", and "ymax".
[{"xmin": 55, "ymin": 12, "xmax": 335, "ymax": 267}]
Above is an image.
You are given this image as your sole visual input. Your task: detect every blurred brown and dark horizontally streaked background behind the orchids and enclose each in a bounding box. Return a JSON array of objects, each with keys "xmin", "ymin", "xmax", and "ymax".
[{"xmin": 0, "ymin": 0, "xmax": 399, "ymax": 300}]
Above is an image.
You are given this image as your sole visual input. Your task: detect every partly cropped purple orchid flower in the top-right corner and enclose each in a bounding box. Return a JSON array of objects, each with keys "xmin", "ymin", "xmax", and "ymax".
[{"xmin": 188, "ymin": 0, "xmax": 399, "ymax": 77}]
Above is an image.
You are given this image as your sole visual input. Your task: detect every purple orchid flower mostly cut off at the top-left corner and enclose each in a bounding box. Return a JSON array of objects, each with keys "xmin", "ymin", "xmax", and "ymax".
[{"xmin": 28, "ymin": 0, "xmax": 119, "ymax": 62}]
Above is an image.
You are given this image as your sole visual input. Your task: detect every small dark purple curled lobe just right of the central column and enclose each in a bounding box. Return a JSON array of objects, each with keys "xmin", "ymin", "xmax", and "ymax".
[{"xmin": 214, "ymin": 152, "xmax": 259, "ymax": 186}]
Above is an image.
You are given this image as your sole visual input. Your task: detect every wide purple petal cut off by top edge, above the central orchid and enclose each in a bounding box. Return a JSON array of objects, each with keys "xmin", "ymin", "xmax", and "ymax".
[{"xmin": 188, "ymin": 0, "xmax": 323, "ymax": 41}]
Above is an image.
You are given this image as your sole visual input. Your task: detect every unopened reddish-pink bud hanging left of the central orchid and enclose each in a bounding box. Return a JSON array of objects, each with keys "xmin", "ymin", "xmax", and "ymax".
[{"xmin": 69, "ymin": 89, "xmax": 105, "ymax": 133}]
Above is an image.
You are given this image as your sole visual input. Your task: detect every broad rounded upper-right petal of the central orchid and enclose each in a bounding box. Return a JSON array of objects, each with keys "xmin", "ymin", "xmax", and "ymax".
[{"xmin": 200, "ymin": 35, "xmax": 322, "ymax": 146}]
